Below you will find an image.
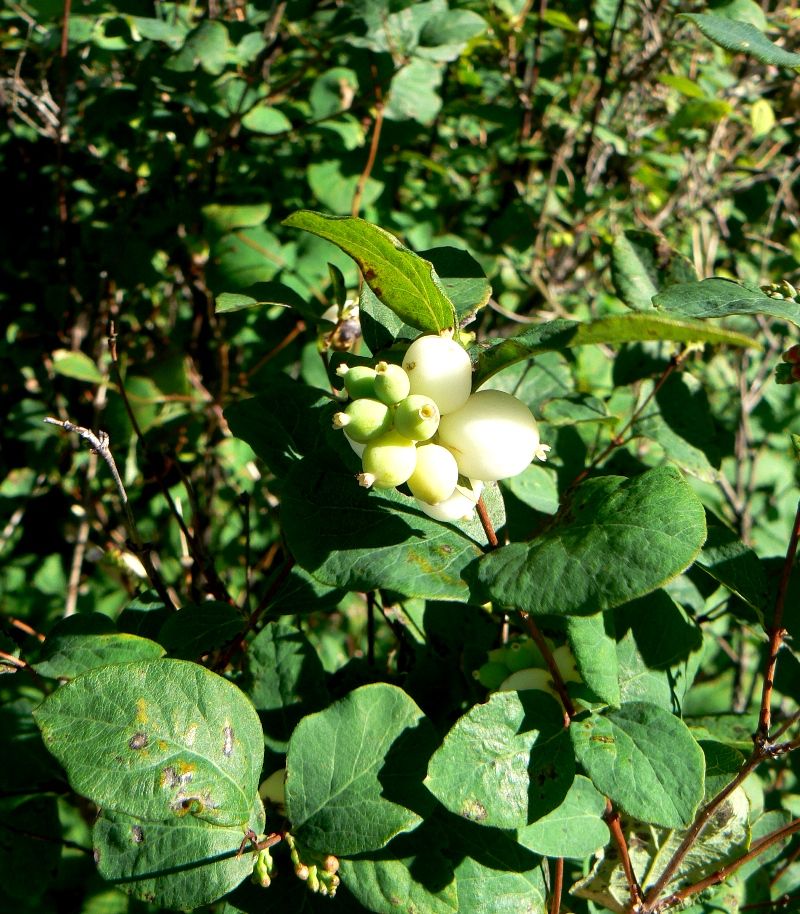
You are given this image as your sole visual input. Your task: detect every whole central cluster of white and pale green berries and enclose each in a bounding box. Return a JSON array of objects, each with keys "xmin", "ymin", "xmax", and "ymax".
[{"xmin": 333, "ymin": 336, "xmax": 549, "ymax": 521}]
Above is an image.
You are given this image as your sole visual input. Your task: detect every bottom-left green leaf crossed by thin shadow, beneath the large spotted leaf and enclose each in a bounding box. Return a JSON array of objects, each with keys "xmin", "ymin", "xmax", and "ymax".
[{"xmin": 93, "ymin": 795, "xmax": 264, "ymax": 911}]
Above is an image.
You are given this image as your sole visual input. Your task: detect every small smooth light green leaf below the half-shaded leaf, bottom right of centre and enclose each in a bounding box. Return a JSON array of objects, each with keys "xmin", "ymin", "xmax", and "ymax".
[{"xmin": 517, "ymin": 775, "xmax": 610, "ymax": 860}]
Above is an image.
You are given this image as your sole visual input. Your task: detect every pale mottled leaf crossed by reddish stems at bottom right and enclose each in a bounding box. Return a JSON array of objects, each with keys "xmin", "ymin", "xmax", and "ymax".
[{"xmin": 571, "ymin": 788, "xmax": 749, "ymax": 914}]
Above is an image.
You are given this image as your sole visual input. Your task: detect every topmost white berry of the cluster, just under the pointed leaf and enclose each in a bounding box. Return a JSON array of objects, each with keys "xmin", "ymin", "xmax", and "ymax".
[{"xmin": 403, "ymin": 336, "xmax": 472, "ymax": 415}]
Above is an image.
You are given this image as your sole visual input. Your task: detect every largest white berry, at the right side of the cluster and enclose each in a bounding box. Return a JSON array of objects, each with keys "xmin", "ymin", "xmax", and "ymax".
[{"xmin": 438, "ymin": 390, "xmax": 541, "ymax": 481}]
